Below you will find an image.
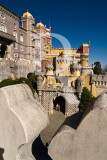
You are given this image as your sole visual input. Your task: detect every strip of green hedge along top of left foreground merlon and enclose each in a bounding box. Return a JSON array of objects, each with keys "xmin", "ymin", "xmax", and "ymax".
[{"xmin": 0, "ymin": 78, "xmax": 35, "ymax": 95}]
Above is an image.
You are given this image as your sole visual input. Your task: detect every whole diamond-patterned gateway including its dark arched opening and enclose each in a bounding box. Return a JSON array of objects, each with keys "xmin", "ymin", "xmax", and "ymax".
[{"xmin": 41, "ymin": 90, "xmax": 79, "ymax": 116}]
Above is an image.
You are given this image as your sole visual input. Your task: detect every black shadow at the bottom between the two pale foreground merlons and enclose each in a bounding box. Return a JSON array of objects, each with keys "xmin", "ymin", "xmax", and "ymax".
[{"xmin": 32, "ymin": 136, "xmax": 52, "ymax": 160}]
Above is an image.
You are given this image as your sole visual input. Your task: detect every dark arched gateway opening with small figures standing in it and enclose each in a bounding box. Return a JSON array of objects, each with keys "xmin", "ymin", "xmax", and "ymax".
[{"xmin": 53, "ymin": 96, "xmax": 66, "ymax": 114}]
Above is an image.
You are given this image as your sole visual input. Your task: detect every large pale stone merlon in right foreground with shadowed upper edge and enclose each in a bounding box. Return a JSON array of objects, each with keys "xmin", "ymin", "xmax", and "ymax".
[{"xmin": 49, "ymin": 93, "xmax": 107, "ymax": 160}]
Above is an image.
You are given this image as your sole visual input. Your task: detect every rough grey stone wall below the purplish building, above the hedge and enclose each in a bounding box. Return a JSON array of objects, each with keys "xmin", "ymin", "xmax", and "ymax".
[{"xmin": 0, "ymin": 58, "xmax": 35, "ymax": 81}]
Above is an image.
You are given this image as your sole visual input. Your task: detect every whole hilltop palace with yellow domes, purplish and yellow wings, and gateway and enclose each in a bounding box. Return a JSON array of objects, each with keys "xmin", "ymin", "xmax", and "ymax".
[{"xmin": 0, "ymin": 4, "xmax": 107, "ymax": 115}]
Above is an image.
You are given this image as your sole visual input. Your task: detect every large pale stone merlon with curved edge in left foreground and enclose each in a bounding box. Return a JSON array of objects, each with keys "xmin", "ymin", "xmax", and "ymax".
[{"xmin": 0, "ymin": 84, "xmax": 48, "ymax": 160}]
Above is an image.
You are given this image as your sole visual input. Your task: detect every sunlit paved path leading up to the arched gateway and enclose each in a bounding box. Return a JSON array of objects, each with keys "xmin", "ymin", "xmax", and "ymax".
[{"xmin": 40, "ymin": 110, "xmax": 65, "ymax": 145}]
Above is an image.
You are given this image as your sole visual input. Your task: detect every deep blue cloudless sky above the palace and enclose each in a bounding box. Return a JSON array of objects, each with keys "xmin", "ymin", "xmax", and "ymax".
[{"xmin": 0, "ymin": 0, "xmax": 107, "ymax": 67}]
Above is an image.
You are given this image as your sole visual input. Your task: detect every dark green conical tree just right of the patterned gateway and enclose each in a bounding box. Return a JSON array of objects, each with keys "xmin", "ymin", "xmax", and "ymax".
[{"xmin": 79, "ymin": 87, "xmax": 94, "ymax": 112}]
